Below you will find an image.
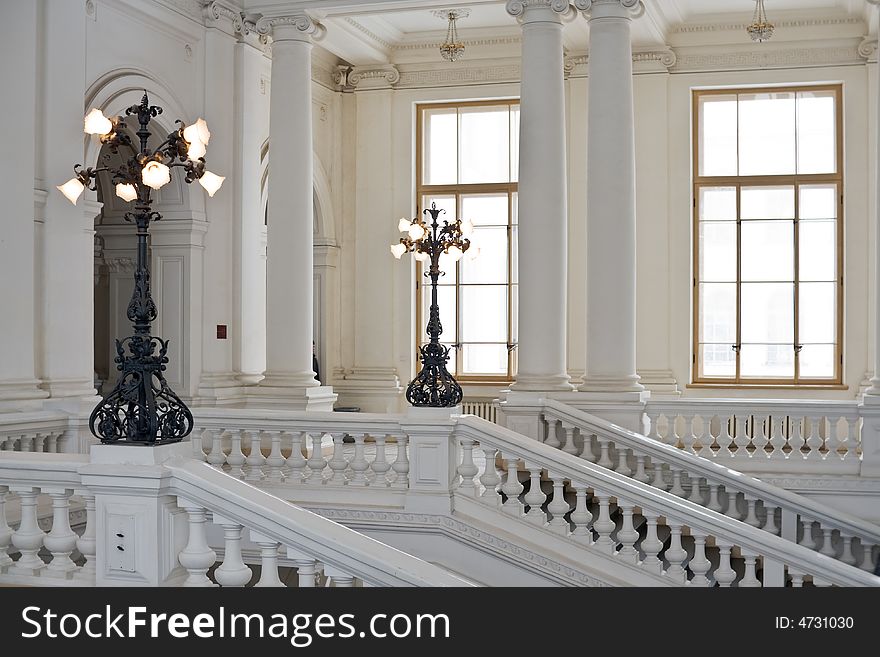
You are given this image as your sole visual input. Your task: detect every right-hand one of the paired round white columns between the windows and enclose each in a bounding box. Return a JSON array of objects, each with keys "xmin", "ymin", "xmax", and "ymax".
[{"xmin": 575, "ymin": 0, "xmax": 645, "ymax": 429}]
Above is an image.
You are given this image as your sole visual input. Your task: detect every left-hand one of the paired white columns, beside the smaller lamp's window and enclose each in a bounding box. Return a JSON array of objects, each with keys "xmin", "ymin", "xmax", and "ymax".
[{"xmin": 507, "ymin": 0, "xmax": 572, "ymax": 392}]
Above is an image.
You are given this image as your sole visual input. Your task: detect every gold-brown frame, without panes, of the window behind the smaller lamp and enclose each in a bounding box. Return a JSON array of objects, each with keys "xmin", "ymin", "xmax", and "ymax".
[{"xmin": 414, "ymin": 98, "xmax": 520, "ymax": 385}]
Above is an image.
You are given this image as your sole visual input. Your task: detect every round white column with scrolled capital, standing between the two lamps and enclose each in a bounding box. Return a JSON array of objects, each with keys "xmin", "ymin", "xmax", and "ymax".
[{"xmin": 254, "ymin": 13, "xmax": 336, "ymax": 410}]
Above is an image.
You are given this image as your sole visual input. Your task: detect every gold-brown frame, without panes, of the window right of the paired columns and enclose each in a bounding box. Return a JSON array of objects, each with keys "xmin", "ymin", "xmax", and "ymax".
[{"xmin": 691, "ymin": 83, "xmax": 845, "ymax": 388}]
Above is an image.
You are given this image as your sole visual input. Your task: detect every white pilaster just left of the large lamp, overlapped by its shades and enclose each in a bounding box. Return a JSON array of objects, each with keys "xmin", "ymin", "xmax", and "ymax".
[{"xmin": 38, "ymin": 0, "xmax": 94, "ymax": 398}]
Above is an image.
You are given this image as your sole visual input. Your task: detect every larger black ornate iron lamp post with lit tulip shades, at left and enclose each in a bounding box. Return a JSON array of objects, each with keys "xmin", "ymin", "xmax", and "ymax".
[{"xmin": 58, "ymin": 92, "xmax": 224, "ymax": 445}]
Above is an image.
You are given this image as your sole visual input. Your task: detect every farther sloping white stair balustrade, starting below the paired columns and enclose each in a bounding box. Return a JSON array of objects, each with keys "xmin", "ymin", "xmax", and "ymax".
[{"xmin": 541, "ymin": 400, "xmax": 880, "ymax": 571}]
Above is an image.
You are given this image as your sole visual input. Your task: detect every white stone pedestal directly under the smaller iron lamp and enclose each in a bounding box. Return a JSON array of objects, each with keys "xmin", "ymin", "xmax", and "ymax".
[{"xmin": 400, "ymin": 406, "xmax": 461, "ymax": 513}]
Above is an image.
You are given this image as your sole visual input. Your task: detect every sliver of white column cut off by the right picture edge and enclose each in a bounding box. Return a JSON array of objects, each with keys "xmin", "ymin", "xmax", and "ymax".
[{"xmin": 861, "ymin": 0, "xmax": 880, "ymax": 477}]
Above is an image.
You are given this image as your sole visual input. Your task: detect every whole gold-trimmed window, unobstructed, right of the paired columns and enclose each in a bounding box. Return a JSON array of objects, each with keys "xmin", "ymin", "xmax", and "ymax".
[{"xmin": 693, "ymin": 85, "xmax": 843, "ymax": 385}]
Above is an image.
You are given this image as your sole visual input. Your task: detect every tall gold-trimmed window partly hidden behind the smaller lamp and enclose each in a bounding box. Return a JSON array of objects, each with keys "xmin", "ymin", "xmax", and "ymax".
[{"xmin": 416, "ymin": 100, "xmax": 519, "ymax": 382}]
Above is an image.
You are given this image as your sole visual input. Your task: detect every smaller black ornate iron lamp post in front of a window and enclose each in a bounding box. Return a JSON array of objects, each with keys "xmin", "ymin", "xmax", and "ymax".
[{"xmin": 391, "ymin": 203, "xmax": 477, "ymax": 407}]
